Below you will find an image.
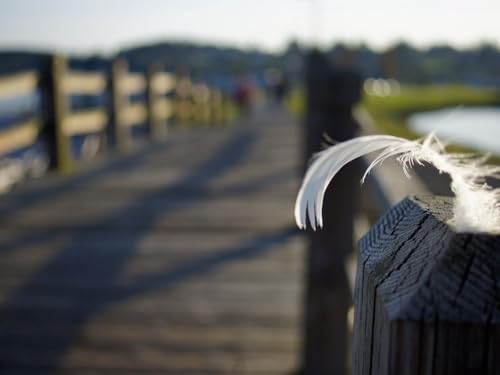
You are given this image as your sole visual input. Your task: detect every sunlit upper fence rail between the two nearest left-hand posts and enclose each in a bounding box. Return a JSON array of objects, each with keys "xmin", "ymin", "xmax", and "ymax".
[{"xmin": 61, "ymin": 71, "xmax": 107, "ymax": 95}]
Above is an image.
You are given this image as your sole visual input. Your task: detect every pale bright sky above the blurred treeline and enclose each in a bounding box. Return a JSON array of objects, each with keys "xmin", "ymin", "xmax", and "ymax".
[{"xmin": 0, "ymin": 0, "xmax": 500, "ymax": 54}]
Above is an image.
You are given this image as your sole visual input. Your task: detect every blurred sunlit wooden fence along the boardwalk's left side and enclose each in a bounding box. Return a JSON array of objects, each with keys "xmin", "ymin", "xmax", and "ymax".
[{"xmin": 0, "ymin": 56, "xmax": 232, "ymax": 181}]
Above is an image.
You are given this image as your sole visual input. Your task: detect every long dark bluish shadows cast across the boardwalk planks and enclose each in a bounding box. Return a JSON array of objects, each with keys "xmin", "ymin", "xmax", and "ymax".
[{"xmin": 0, "ymin": 104, "xmax": 297, "ymax": 372}]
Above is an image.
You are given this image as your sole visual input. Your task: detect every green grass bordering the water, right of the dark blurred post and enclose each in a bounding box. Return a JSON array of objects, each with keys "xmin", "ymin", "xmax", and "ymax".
[{"xmin": 362, "ymin": 85, "xmax": 500, "ymax": 138}]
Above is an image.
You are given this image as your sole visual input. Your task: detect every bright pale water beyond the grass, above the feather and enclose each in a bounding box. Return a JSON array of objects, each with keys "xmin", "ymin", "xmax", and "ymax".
[{"xmin": 408, "ymin": 107, "xmax": 500, "ymax": 155}]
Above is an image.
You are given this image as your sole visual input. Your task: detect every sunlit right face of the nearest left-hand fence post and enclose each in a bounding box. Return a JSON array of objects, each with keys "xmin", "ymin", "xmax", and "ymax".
[{"xmin": 51, "ymin": 56, "xmax": 73, "ymax": 173}]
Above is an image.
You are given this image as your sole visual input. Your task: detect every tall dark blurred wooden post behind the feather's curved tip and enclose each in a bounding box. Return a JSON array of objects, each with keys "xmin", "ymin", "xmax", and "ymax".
[{"xmin": 302, "ymin": 52, "xmax": 361, "ymax": 375}]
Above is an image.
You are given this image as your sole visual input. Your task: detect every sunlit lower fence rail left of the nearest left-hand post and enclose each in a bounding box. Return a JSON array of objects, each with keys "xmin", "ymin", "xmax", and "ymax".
[{"xmin": 0, "ymin": 119, "xmax": 40, "ymax": 155}]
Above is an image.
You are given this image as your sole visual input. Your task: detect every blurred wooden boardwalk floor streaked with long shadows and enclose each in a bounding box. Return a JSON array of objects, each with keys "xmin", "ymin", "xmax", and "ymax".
[{"xmin": 0, "ymin": 108, "xmax": 304, "ymax": 375}]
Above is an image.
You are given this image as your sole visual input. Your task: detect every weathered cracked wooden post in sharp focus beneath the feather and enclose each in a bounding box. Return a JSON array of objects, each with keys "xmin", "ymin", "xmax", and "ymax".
[{"xmin": 353, "ymin": 197, "xmax": 500, "ymax": 375}]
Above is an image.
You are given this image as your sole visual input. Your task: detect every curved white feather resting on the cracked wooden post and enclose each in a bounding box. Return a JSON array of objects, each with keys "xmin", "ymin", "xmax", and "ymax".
[{"xmin": 295, "ymin": 133, "xmax": 500, "ymax": 232}]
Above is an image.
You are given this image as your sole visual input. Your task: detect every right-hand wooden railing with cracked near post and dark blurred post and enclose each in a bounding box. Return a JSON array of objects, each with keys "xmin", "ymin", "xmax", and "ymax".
[{"xmin": 301, "ymin": 50, "xmax": 500, "ymax": 375}]
